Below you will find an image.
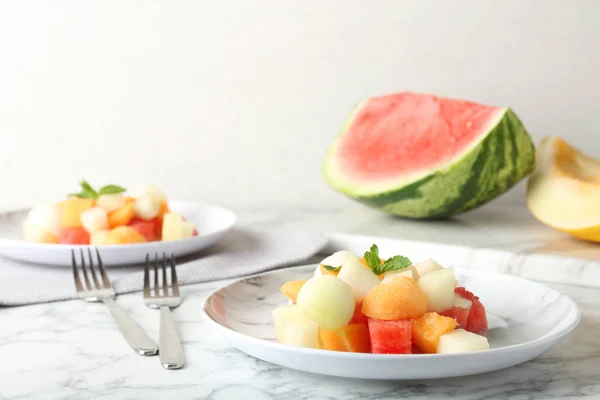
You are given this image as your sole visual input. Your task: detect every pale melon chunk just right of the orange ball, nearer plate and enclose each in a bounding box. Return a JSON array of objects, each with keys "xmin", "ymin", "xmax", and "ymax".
[{"xmin": 417, "ymin": 268, "xmax": 455, "ymax": 312}]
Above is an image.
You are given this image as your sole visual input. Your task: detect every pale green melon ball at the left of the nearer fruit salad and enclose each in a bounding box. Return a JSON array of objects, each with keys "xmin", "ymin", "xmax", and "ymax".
[{"xmin": 296, "ymin": 275, "xmax": 355, "ymax": 329}]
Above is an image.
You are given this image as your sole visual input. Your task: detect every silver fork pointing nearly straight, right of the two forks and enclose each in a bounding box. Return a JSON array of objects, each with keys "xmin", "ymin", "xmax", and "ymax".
[{"xmin": 144, "ymin": 253, "xmax": 183, "ymax": 369}]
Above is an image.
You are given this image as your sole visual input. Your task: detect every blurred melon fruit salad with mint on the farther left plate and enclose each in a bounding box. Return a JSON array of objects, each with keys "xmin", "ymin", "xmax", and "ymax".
[{"xmin": 23, "ymin": 181, "xmax": 198, "ymax": 246}]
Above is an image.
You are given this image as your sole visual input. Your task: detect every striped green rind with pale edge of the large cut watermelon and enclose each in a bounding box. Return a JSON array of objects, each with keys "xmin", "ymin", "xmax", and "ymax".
[{"xmin": 324, "ymin": 108, "xmax": 535, "ymax": 219}]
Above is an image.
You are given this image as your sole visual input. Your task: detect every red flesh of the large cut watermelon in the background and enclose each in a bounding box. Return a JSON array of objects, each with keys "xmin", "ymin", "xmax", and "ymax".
[{"xmin": 338, "ymin": 93, "xmax": 503, "ymax": 180}]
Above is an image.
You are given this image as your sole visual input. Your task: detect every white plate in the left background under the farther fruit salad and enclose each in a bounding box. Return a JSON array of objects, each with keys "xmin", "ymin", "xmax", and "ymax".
[{"xmin": 0, "ymin": 201, "xmax": 236, "ymax": 266}]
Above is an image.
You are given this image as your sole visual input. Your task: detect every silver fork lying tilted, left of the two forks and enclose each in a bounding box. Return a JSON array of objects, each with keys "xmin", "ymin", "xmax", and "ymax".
[{"xmin": 71, "ymin": 247, "xmax": 158, "ymax": 356}]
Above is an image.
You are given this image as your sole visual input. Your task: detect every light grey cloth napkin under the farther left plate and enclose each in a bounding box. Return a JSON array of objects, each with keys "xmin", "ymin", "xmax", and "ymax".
[{"xmin": 0, "ymin": 228, "xmax": 327, "ymax": 306}]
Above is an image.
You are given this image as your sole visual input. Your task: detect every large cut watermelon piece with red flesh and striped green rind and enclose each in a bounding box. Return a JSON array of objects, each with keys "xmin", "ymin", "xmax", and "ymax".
[{"xmin": 323, "ymin": 93, "xmax": 534, "ymax": 218}]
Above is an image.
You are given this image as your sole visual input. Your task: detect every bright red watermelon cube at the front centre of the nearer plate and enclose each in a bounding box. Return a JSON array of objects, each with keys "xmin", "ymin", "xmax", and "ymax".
[{"xmin": 369, "ymin": 318, "xmax": 412, "ymax": 354}]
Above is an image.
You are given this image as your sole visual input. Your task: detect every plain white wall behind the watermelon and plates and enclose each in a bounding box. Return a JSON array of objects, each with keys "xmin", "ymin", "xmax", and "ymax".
[{"xmin": 0, "ymin": 0, "xmax": 600, "ymax": 209}]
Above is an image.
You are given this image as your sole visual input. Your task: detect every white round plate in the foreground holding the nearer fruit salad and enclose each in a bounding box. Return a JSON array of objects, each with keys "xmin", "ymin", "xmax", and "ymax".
[{"xmin": 202, "ymin": 266, "xmax": 581, "ymax": 379}]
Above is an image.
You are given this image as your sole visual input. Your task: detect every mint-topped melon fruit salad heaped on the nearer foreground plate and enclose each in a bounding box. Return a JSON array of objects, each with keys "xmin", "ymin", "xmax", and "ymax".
[{"xmin": 273, "ymin": 245, "xmax": 490, "ymax": 354}]
